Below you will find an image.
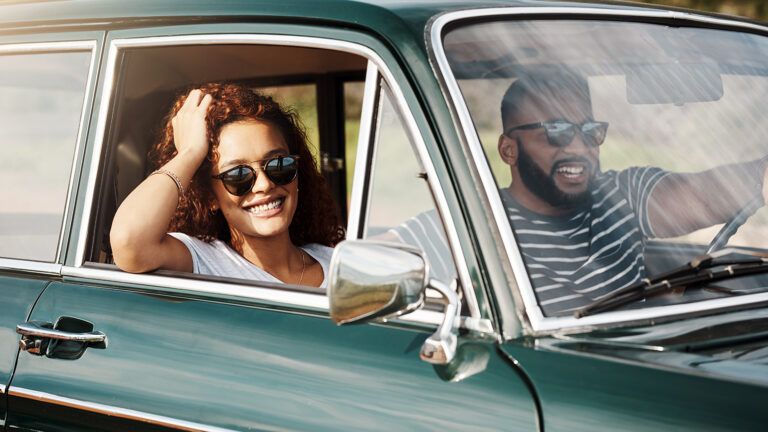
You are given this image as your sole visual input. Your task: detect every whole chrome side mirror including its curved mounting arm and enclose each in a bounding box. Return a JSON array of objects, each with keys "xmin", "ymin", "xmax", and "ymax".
[{"xmin": 328, "ymin": 240, "xmax": 459, "ymax": 364}]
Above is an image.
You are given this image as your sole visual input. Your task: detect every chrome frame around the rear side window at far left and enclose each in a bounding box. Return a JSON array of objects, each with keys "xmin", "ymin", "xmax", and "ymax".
[{"xmin": 0, "ymin": 38, "xmax": 103, "ymax": 275}]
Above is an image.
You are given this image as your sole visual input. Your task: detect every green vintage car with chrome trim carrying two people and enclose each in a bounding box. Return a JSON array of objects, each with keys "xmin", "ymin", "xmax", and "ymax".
[{"xmin": 0, "ymin": 0, "xmax": 768, "ymax": 431}]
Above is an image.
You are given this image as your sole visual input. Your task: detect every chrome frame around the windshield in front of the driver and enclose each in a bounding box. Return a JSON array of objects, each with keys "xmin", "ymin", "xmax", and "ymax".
[{"xmin": 427, "ymin": 6, "xmax": 768, "ymax": 340}]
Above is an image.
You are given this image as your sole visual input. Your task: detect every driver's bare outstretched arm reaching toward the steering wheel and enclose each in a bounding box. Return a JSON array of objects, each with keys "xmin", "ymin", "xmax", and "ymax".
[{"xmin": 648, "ymin": 157, "xmax": 768, "ymax": 237}]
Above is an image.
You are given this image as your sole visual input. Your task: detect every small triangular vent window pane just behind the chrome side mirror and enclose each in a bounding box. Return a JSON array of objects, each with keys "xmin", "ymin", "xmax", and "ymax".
[{"xmin": 364, "ymin": 83, "xmax": 456, "ymax": 283}]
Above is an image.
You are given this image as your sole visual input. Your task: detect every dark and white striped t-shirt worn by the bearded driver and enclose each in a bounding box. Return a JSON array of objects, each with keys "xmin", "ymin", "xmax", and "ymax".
[{"xmin": 502, "ymin": 167, "xmax": 667, "ymax": 316}]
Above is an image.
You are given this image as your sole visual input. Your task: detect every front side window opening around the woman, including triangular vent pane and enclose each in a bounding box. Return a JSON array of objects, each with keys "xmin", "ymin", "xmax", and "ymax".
[{"xmin": 86, "ymin": 36, "xmax": 464, "ymax": 307}]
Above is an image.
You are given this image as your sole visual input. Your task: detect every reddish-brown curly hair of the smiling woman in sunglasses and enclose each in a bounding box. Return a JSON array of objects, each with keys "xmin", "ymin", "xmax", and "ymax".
[{"xmin": 150, "ymin": 83, "xmax": 344, "ymax": 249}]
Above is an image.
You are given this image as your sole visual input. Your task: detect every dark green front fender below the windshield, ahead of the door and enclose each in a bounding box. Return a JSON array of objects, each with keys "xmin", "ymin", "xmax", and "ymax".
[{"xmin": 502, "ymin": 338, "xmax": 768, "ymax": 431}]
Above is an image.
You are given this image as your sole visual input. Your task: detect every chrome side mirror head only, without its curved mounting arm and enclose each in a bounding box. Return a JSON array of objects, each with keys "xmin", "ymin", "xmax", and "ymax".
[{"xmin": 328, "ymin": 240, "xmax": 427, "ymax": 324}]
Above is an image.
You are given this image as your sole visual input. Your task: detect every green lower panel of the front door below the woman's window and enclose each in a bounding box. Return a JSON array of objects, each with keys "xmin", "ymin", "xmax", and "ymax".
[{"xmin": 8, "ymin": 283, "xmax": 536, "ymax": 430}]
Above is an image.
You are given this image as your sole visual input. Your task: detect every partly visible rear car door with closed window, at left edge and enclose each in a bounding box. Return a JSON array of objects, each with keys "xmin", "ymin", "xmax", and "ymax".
[{"xmin": 0, "ymin": 32, "xmax": 102, "ymax": 424}]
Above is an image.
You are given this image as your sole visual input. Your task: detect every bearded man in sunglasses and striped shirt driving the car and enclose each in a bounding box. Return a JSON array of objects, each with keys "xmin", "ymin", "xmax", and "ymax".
[{"xmin": 498, "ymin": 73, "xmax": 768, "ymax": 315}]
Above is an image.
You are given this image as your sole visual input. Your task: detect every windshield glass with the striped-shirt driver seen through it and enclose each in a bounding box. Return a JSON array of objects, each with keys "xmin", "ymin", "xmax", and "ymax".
[{"xmin": 444, "ymin": 19, "xmax": 768, "ymax": 316}]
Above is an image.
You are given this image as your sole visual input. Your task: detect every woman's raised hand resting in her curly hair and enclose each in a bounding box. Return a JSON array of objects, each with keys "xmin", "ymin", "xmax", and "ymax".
[{"xmin": 171, "ymin": 89, "xmax": 213, "ymax": 162}]
